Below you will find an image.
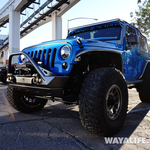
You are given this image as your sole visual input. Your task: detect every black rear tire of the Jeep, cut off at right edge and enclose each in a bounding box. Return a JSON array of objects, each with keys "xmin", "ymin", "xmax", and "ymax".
[{"xmin": 136, "ymin": 69, "xmax": 150, "ymax": 103}]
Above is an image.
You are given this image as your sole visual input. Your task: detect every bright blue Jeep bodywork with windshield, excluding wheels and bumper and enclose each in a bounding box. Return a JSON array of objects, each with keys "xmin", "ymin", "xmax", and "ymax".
[{"xmin": 19, "ymin": 21, "xmax": 150, "ymax": 80}]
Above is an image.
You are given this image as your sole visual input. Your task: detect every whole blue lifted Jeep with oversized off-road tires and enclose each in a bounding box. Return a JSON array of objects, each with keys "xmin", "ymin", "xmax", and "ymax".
[{"xmin": 7, "ymin": 19, "xmax": 150, "ymax": 136}]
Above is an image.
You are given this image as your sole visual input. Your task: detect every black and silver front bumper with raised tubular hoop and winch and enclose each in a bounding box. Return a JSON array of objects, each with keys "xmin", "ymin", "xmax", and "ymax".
[{"xmin": 7, "ymin": 52, "xmax": 69, "ymax": 97}]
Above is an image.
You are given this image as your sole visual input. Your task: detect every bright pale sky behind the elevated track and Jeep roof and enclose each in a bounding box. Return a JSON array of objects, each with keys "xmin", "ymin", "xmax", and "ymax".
[{"xmin": 0, "ymin": 0, "xmax": 138, "ymax": 50}]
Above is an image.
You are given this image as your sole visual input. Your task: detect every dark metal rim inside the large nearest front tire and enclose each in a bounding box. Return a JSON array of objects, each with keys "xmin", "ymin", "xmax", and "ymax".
[{"xmin": 106, "ymin": 84, "xmax": 122, "ymax": 120}]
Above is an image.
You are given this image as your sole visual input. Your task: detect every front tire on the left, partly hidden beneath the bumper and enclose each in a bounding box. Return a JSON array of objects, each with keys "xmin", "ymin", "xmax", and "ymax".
[{"xmin": 7, "ymin": 85, "xmax": 47, "ymax": 113}]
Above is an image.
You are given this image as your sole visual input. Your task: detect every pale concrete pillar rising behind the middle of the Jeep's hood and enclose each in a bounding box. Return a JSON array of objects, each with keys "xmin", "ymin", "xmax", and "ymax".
[{"xmin": 52, "ymin": 12, "xmax": 62, "ymax": 40}]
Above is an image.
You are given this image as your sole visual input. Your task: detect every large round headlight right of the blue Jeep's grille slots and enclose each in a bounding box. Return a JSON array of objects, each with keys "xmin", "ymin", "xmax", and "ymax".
[{"xmin": 60, "ymin": 45, "xmax": 71, "ymax": 59}]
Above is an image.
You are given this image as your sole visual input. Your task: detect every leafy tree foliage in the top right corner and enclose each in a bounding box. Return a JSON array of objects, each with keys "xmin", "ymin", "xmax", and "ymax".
[{"xmin": 130, "ymin": 0, "xmax": 150, "ymax": 37}]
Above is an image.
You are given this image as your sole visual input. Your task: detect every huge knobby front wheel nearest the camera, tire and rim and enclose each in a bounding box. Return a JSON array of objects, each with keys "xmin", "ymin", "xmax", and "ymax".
[{"xmin": 79, "ymin": 68, "xmax": 128, "ymax": 136}]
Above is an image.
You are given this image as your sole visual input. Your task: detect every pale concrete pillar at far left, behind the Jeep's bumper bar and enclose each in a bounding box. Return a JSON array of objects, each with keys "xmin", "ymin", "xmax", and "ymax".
[{"xmin": 9, "ymin": 5, "xmax": 20, "ymax": 55}]
